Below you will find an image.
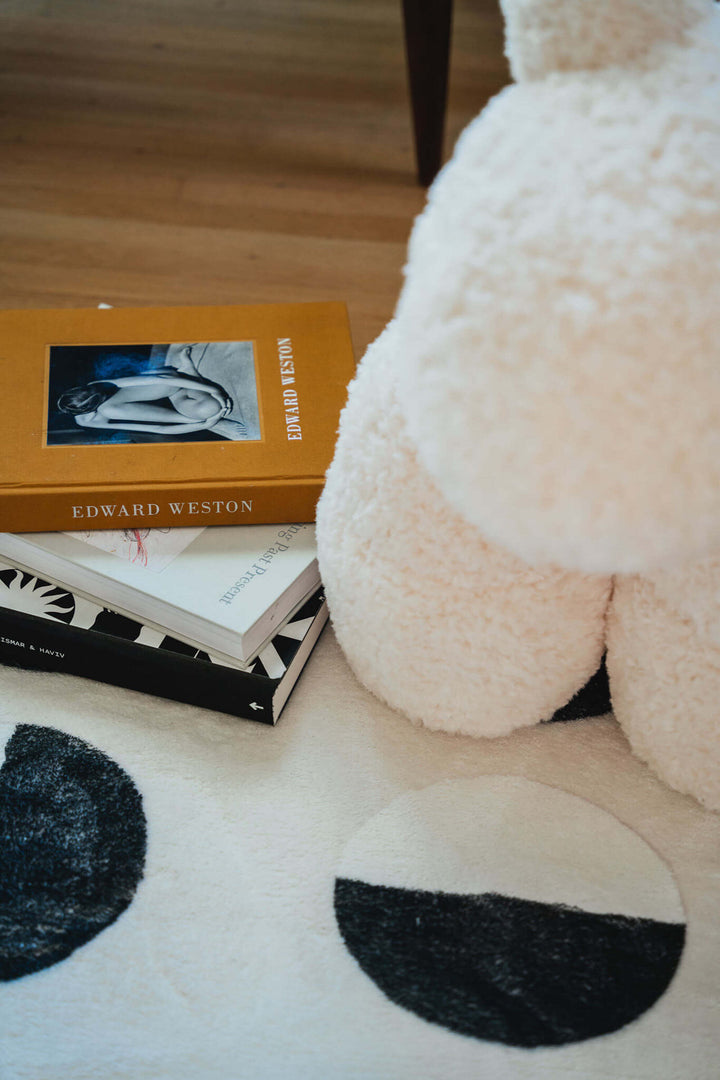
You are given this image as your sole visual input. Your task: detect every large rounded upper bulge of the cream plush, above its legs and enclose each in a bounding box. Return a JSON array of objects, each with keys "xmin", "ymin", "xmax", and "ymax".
[{"xmin": 394, "ymin": 0, "xmax": 720, "ymax": 573}]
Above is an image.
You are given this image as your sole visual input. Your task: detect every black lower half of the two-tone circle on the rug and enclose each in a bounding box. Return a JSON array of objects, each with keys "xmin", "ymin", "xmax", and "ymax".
[{"xmin": 335, "ymin": 878, "xmax": 685, "ymax": 1048}]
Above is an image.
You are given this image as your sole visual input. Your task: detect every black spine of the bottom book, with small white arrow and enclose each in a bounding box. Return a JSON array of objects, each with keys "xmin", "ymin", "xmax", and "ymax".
[{"xmin": 0, "ymin": 608, "xmax": 280, "ymax": 724}]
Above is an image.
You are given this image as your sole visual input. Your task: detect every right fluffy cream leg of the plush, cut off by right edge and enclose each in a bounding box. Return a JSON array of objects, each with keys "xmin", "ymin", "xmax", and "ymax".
[{"xmin": 608, "ymin": 576, "xmax": 720, "ymax": 810}]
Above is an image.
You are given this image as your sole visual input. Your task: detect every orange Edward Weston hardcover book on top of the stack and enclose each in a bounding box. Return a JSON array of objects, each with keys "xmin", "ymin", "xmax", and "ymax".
[{"xmin": 0, "ymin": 302, "xmax": 355, "ymax": 532}]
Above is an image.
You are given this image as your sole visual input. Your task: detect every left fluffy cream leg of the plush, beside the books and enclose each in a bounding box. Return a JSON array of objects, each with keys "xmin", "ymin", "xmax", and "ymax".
[{"xmin": 317, "ymin": 324, "xmax": 610, "ymax": 735}]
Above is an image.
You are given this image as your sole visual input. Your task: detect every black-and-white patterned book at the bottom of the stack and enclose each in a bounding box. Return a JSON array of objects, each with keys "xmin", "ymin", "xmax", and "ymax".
[{"xmin": 0, "ymin": 559, "xmax": 327, "ymax": 724}]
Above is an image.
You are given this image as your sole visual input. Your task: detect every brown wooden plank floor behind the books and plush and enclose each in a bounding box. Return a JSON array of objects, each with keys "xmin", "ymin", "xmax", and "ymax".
[{"xmin": 0, "ymin": 0, "xmax": 507, "ymax": 355}]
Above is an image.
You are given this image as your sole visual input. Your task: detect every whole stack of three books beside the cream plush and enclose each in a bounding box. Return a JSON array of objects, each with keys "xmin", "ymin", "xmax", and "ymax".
[{"xmin": 0, "ymin": 303, "xmax": 354, "ymax": 724}]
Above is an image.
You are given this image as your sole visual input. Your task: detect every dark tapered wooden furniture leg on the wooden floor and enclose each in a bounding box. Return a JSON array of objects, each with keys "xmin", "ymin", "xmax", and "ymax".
[{"xmin": 403, "ymin": 0, "xmax": 452, "ymax": 187}]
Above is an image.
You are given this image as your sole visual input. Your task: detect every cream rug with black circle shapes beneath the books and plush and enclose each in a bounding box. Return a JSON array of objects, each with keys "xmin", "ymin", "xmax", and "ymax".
[{"xmin": 0, "ymin": 627, "xmax": 720, "ymax": 1080}]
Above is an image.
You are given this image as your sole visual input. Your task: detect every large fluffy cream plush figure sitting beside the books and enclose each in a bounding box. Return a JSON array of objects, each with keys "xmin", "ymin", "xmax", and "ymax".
[{"xmin": 317, "ymin": 0, "xmax": 720, "ymax": 808}]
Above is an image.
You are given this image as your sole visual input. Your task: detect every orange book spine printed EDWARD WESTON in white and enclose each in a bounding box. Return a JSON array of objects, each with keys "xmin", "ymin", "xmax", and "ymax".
[{"xmin": 0, "ymin": 477, "xmax": 323, "ymax": 532}]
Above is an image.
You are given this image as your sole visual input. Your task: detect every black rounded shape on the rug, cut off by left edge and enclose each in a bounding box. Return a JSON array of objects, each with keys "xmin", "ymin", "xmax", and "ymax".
[{"xmin": 0, "ymin": 725, "xmax": 147, "ymax": 982}]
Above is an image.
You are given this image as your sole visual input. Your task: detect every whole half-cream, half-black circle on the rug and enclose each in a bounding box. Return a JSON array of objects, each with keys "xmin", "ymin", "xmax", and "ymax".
[{"xmin": 335, "ymin": 777, "xmax": 685, "ymax": 1048}]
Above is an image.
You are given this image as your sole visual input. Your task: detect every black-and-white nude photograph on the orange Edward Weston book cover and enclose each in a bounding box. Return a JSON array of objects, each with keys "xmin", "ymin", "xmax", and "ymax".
[{"xmin": 46, "ymin": 341, "xmax": 261, "ymax": 446}]
